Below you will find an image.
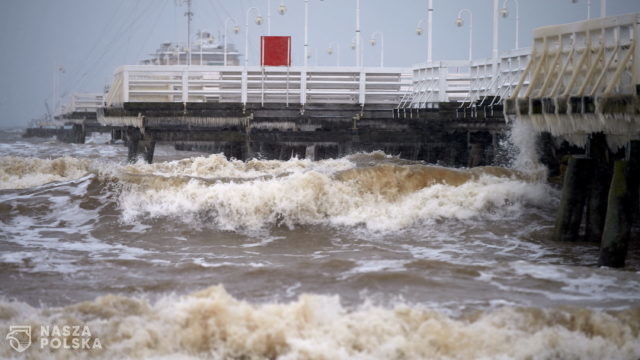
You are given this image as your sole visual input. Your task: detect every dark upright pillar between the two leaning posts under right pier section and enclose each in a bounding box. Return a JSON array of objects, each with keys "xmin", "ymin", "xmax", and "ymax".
[{"xmin": 585, "ymin": 133, "xmax": 612, "ymax": 243}]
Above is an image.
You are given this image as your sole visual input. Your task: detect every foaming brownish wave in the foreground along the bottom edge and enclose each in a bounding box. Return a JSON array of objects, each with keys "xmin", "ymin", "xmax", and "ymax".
[{"xmin": 0, "ymin": 286, "xmax": 640, "ymax": 359}]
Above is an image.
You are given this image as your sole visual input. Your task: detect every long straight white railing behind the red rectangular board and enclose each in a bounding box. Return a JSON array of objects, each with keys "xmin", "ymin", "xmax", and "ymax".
[{"xmin": 105, "ymin": 65, "xmax": 411, "ymax": 106}]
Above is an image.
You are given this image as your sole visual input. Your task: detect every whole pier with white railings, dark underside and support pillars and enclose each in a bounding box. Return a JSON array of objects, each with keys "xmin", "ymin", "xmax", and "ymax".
[{"xmin": 21, "ymin": 9, "xmax": 640, "ymax": 267}]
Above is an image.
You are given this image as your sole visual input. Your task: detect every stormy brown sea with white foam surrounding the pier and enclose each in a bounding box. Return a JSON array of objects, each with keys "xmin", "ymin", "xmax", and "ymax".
[{"xmin": 0, "ymin": 122, "xmax": 640, "ymax": 359}]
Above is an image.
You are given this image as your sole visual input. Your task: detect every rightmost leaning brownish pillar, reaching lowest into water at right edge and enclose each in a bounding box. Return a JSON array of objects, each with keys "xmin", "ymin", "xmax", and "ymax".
[{"xmin": 598, "ymin": 160, "xmax": 633, "ymax": 267}]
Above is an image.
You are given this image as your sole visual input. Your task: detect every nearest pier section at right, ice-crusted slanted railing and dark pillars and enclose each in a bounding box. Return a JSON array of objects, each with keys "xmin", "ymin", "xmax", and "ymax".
[{"xmin": 505, "ymin": 14, "xmax": 640, "ymax": 267}]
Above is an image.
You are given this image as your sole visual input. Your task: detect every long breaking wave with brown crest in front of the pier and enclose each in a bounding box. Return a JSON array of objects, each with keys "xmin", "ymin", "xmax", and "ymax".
[{"xmin": 120, "ymin": 155, "xmax": 553, "ymax": 231}]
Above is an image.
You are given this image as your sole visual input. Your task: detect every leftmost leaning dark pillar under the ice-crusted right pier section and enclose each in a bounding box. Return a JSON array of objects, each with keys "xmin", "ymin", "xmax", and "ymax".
[{"xmin": 553, "ymin": 156, "xmax": 592, "ymax": 241}]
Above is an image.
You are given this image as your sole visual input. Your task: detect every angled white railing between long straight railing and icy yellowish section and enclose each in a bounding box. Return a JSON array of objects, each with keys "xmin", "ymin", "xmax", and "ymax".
[{"xmin": 398, "ymin": 48, "xmax": 531, "ymax": 109}]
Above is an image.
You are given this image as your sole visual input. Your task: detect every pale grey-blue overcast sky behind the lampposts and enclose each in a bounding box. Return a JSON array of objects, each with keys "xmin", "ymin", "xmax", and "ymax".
[{"xmin": 0, "ymin": 0, "xmax": 640, "ymax": 127}]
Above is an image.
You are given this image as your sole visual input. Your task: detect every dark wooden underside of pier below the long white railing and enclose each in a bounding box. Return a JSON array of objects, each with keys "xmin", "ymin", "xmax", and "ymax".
[{"xmin": 103, "ymin": 102, "xmax": 506, "ymax": 166}]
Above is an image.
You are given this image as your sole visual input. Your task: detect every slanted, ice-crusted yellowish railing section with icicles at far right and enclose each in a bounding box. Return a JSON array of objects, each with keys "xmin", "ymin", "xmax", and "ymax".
[{"xmin": 505, "ymin": 13, "xmax": 640, "ymax": 136}]
